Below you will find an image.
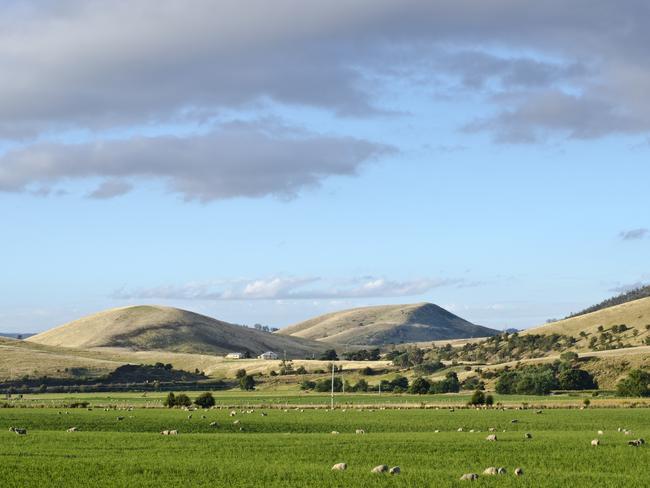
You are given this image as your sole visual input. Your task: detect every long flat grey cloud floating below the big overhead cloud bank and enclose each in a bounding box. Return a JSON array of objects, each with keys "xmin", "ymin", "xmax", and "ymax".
[{"xmin": 0, "ymin": 124, "xmax": 393, "ymax": 202}]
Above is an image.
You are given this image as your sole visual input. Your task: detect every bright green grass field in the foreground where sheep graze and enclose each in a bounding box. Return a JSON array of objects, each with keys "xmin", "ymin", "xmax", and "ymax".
[{"xmin": 0, "ymin": 396, "xmax": 650, "ymax": 488}]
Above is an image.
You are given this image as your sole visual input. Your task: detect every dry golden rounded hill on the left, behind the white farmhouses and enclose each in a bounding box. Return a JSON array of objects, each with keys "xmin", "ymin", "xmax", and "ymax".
[{"xmin": 27, "ymin": 305, "xmax": 324, "ymax": 357}]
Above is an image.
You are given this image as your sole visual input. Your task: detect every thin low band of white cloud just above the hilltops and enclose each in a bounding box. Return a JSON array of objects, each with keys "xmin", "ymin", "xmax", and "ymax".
[{"xmin": 113, "ymin": 277, "xmax": 462, "ymax": 300}]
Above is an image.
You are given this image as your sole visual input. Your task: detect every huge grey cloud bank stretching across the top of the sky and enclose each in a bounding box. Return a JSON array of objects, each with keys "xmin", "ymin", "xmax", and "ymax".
[{"xmin": 0, "ymin": 0, "xmax": 650, "ymax": 142}]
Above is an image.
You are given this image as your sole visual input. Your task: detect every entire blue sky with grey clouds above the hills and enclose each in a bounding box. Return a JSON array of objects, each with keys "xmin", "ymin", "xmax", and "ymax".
[{"xmin": 0, "ymin": 0, "xmax": 650, "ymax": 332}]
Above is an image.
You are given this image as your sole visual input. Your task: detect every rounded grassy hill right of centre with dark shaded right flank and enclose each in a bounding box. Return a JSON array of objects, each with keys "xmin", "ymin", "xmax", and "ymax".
[{"xmin": 276, "ymin": 303, "xmax": 499, "ymax": 346}]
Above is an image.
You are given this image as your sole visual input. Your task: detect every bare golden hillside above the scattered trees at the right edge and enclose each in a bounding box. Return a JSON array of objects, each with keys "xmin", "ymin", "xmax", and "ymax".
[{"xmin": 521, "ymin": 298, "xmax": 650, "ymax": 349}]
